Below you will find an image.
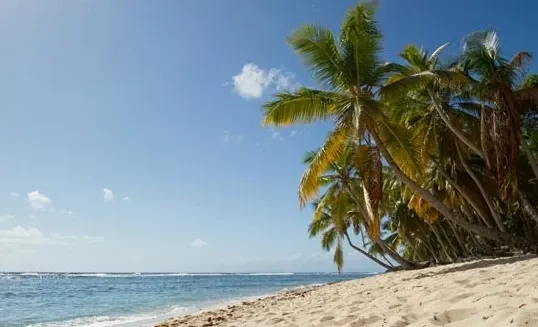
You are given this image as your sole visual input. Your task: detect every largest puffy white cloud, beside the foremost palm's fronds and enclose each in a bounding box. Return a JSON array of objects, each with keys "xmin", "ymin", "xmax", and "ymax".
[{"xmin": 232, "ymin": 63, "xmax": 295, "ymax": 99}]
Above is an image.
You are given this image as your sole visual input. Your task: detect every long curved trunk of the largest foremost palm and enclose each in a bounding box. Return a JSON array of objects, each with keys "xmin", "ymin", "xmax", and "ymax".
[{"xmin": 370, "ymin": 130, "xmax": 510, "ymax": 243}]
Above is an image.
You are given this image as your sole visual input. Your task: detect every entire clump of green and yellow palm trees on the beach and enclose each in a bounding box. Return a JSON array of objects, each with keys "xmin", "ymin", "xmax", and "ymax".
[{"xmin": 263, "ymin": 4, "xmax": 538, "ymax": 270}]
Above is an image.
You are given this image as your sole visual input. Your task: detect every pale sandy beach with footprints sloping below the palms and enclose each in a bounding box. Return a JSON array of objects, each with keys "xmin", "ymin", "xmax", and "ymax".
[{"xmin": 157, "ymin": 257, "xmax": 538, "ymax": 327}]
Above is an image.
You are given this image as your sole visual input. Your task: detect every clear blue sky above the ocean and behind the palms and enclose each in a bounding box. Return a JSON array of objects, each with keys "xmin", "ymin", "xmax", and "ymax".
[{"xmin": 0, "ymin": 0, "xmax": 538, "ymax": 271}]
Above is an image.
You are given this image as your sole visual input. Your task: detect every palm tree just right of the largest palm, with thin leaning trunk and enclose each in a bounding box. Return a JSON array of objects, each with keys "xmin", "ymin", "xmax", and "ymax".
[{"xmin": 382, "ymin": 44, "xmax": 506, "ymax": 232}]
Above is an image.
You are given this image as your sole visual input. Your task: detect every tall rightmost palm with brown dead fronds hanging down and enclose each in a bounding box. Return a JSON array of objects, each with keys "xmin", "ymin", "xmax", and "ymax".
[{"xmin": 459, "ymin": 31, "xmax": 538, "ymax": 196}]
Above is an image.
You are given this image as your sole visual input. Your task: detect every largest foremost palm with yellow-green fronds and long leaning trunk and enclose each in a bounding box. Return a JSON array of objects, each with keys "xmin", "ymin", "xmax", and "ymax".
[{"xmin": 263, "ymin": 4, "xmax": 514, "ymax": 242}]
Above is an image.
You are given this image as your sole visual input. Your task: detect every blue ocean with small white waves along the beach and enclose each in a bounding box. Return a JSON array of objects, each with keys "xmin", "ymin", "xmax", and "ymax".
[{"xmin": 0, "ymin": 273, "xmax": 368, "ymax": 327}]
